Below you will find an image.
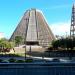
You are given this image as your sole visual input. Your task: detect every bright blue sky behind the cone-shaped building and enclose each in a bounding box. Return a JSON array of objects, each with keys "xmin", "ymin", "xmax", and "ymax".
[{"xmin": 0, "ymin": 0, "xmax": 75, "ymax": 38}]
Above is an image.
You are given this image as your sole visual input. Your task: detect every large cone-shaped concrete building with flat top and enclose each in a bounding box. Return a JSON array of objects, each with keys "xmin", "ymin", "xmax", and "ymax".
[{"xmin": 10, "ymin": 9, "xmax": 55, "ymax": 46}]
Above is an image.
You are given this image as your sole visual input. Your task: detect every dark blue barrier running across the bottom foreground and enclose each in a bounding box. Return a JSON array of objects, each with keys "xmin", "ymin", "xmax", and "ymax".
[{"xmin": 0, "ymin": 63, "xmax": 75, "ymax": 75}]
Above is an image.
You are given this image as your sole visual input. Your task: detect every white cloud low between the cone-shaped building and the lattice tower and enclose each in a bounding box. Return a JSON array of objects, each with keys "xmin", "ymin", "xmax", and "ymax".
[{"xmin": 50, "ymin": 22, "xmax": 70, "ymax": 36}]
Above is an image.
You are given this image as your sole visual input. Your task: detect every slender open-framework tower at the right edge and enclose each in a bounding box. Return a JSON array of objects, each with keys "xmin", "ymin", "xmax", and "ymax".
[{"xmin": 70, "ymin": 4, "xmax": 75, "ymax": 39}]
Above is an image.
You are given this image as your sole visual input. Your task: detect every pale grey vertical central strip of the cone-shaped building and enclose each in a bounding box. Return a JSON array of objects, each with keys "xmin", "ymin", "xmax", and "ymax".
[{"xmin": 26, "ymin": 9, "xmax": 37, "ymax": 42}]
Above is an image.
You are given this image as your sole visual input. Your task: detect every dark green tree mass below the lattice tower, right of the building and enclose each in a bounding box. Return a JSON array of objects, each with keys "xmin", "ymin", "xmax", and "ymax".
[{"xmin": 52, "ymin": 38, "xmax": 75, "ymax": 50}]
